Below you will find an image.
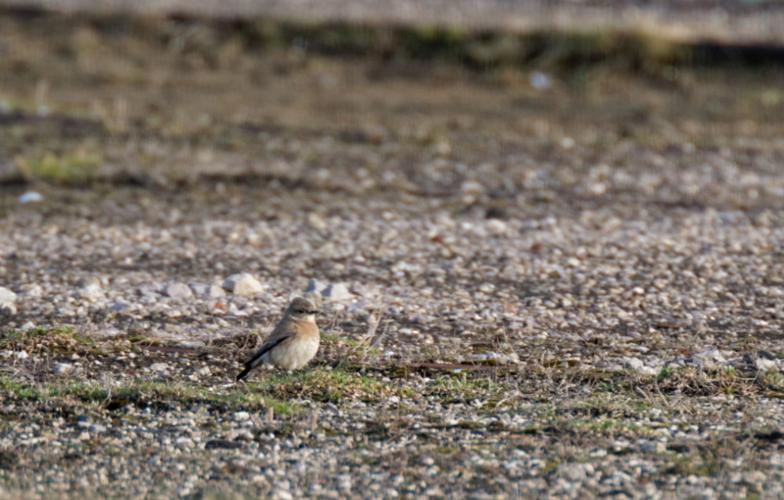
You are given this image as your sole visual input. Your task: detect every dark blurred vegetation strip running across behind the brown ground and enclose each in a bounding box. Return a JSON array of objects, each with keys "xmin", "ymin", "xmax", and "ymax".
[{"xmin": 0, "ymin": 7, "xmax": 784, "ymax": 71}]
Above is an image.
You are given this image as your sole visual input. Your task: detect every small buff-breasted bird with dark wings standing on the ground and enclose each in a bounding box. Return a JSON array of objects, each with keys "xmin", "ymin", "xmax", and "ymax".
[{"xmin": 237, "ymin": 297, "xmax": 320, "ymax": 381}]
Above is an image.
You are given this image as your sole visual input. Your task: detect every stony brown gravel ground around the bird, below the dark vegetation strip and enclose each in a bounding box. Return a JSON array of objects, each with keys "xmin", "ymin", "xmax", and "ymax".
[{"xmin": 0, "ymin": 8, "xmax": 784, "ymax": 498}]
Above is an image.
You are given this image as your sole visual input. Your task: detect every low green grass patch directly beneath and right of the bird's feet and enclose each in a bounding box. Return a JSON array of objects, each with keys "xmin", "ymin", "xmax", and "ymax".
[{"xmin": 248, "ymin": 367, "xmax": 395, "ymax": 403}]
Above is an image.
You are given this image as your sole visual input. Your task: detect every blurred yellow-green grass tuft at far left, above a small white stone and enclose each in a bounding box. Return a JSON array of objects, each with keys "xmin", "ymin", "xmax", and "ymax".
[{"xmin": 16, "ymin": 150, "xmax": 103, "ymax": 186}]
